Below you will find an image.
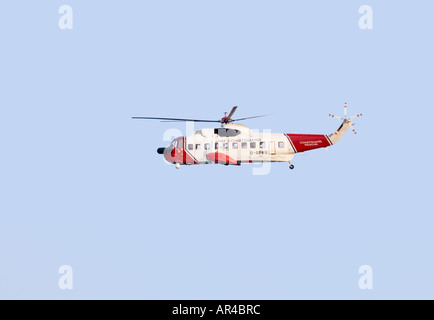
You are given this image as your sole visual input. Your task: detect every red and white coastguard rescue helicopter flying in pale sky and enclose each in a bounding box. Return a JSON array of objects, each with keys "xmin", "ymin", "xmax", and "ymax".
[{"xmin": 132, "ymin": 103, "xmax": 362, "ymax": 169}]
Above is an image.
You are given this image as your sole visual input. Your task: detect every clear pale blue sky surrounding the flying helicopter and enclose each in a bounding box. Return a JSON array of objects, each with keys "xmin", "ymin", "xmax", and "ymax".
[{"xmin": 0, "ymin": 0, "xmax": 434, "ymax": 299}]
